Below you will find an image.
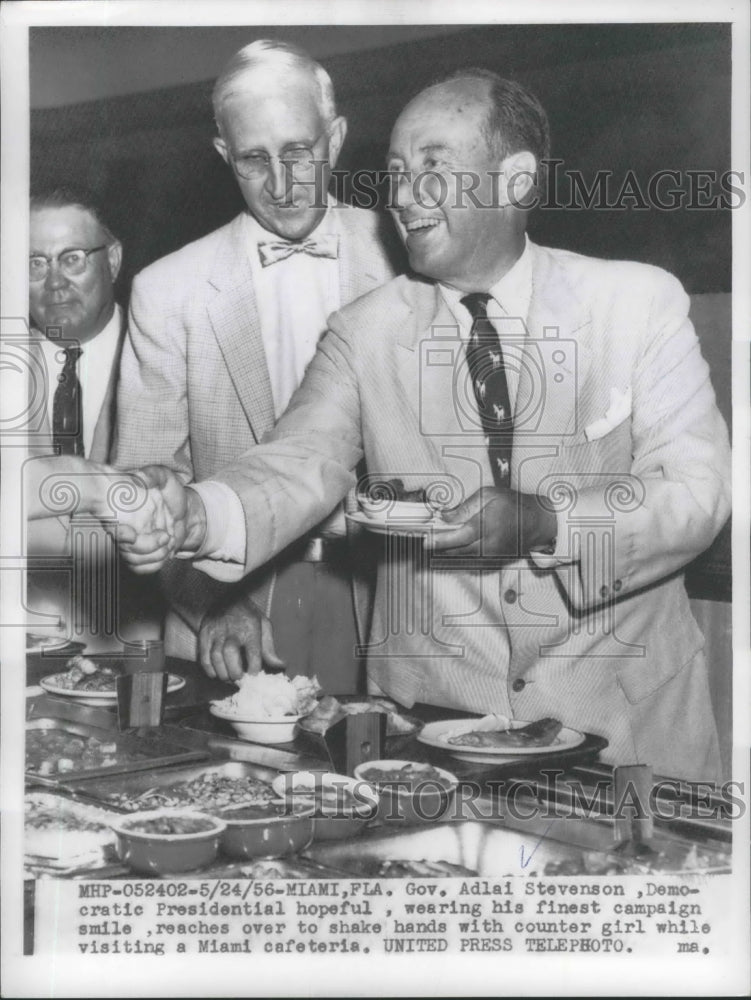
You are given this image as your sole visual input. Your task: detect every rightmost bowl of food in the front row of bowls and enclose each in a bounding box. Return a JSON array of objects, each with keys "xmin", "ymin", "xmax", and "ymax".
[{"xmin": 354, "ymin": 760, "xmax": 459, "ymax": 823}]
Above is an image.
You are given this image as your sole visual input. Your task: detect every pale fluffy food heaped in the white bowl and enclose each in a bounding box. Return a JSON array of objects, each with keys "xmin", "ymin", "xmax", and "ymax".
[{"xmin": 211, "ymin": 672, "xmax": 321, "ymax": 721}]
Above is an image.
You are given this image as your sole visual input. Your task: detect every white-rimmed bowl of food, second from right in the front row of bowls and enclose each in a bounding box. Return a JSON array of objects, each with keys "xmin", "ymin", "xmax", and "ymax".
[{"xmin": 271, "ymin": 771, "xmax": 378, "ymax": 840}]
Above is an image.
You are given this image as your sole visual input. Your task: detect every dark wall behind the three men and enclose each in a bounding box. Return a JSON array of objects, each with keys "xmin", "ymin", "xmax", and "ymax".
[{"xmin": 29, "ymin": 24, "xmax": 732, "ymax": 600}]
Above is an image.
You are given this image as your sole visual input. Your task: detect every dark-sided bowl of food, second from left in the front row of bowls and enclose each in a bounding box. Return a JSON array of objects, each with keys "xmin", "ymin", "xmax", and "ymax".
[{"xmin": 219, "ymin": 799, "xmax": 315, "ymax": 859}]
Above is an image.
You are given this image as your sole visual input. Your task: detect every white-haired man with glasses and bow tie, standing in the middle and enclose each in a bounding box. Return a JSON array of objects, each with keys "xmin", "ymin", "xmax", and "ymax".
[{"xmin": 115, "ymin": 41, "xmax": 393, "ymax": 693}]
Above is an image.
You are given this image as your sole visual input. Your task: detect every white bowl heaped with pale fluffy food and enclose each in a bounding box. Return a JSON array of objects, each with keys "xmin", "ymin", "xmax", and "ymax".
[{"xmin": 209, "ymin": 672, "xmax": 321, "ymax": 744}]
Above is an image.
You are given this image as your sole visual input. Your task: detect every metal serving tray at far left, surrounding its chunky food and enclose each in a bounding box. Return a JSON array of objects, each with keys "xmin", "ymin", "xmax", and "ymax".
[{"xmin": 26, "ymin": 718, "xmax": 209, "ymax": 788}]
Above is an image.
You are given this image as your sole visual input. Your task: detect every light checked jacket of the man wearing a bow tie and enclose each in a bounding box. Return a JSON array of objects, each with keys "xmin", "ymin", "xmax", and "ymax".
[{"xmin": 114, "ymin": 204, "xmax": 394, "ymax": 659}]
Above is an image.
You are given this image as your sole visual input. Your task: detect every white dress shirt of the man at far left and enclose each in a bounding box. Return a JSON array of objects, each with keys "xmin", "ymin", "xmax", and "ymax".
[{"xmin": 39, "ymin": 305, "xmax": 122, "ymax": 458}]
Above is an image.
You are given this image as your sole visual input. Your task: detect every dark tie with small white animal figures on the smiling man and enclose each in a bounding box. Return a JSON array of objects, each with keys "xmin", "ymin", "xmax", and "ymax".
[{"xmin": 461, "ymin": 292, "xmax": 514, "ymax": 487}]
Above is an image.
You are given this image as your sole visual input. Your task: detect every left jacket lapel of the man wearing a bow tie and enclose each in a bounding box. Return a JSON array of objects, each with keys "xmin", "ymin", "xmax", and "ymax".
[{"xmin": 207, "ymin": 215, "xmax": 274, "ymax": 441}]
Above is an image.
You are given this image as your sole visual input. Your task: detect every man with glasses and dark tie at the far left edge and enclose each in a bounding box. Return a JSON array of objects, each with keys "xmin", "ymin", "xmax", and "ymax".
[{"xmin": 26, "ymin": 187, "xmax": 158, "ymax": 650}]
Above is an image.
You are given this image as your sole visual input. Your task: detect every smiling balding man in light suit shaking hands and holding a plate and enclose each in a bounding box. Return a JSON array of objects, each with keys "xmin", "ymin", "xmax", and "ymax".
[{"xmin": 129, "ymin": 70, "xmax": 730, "ymax": 780}]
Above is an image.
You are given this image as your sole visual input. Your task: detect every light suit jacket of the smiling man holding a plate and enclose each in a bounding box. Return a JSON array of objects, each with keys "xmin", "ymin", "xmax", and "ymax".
[{"xmin": 216, "ymin": 245, "xmax": 730, "ymax": 778}]
